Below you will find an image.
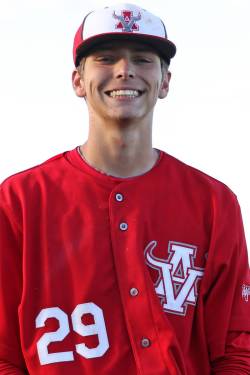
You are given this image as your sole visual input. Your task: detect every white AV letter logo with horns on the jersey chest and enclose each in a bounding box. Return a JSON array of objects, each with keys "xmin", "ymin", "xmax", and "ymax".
[{"xmin": 145, "ymin": 241, "xmax": 204, "ymax": 316}]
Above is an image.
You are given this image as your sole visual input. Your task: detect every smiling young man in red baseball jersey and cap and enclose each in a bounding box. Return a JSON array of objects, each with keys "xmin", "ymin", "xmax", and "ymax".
[{"xmin": 0, "ymin": 4, "xmax": 250, "ymax": 375}]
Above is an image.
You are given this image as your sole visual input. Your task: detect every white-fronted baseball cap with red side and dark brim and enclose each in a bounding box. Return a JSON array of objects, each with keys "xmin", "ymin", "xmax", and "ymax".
[{"xmin": 73, "ymin": 4, "xmax": 176, "ymax": 67}]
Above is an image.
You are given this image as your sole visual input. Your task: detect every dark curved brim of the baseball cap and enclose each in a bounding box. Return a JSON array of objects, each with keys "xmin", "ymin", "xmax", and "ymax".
[{"xmin": 75, "ymin": 32, "xmax": 176, "ymax": 66}]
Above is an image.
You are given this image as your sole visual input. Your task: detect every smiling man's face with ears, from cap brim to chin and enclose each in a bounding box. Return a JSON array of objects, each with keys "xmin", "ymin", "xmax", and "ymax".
[{"xmin": 73, "ymin": 41, "xmax": 170, "ymax": 122}]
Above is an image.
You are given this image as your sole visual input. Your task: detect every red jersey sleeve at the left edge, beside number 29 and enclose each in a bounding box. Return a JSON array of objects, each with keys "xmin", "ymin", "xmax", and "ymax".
[{"xmin": 0, "ymin": 188, "xmax": 26, "ymax": 375}]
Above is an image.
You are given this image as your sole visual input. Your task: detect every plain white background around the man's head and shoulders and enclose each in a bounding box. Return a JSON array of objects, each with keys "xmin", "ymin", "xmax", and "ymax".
[{"xmin": 0, "ymin": 0, "xmax": 250, "ymax": 256}]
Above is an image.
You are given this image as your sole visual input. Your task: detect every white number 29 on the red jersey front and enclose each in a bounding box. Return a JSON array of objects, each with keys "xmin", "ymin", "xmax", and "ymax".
[{"xmin": 36, "ymin": 302, "xmax": 109, "ymax": 365}]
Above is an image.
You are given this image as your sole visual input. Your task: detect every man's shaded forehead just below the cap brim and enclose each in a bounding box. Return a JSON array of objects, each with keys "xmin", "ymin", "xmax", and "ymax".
[{"xmin": 87, "ymin": 40, "xmax": 159, "ymax": 56}]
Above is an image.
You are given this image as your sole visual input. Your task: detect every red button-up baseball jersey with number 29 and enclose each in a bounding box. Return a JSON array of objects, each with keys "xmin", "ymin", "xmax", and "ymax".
[{"xmin": 0, "ymin": 149, "xmax": 250, "ymax": 375}]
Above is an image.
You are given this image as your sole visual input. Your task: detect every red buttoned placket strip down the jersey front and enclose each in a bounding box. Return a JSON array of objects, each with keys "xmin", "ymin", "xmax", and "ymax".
[{"xmin": 110, "ymin": 190, "xmax": 160, "ymax": 367}]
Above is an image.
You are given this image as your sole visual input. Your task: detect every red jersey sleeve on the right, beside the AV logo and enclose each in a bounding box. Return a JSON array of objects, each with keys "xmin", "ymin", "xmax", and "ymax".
[{"xmin": 204, "ymin": 193, "xmax": 250, "ymax": 364}]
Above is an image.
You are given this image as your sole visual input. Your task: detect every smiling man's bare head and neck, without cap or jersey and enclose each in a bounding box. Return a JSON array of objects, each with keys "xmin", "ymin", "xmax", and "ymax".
[{"xmin": 73, "ymin": 37, "xmax": 170, "ymax": 177}]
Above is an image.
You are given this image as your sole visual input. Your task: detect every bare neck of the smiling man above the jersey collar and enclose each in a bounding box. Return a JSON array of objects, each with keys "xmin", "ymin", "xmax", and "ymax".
[{"xmin": 80, "ymin": 118, "xmax": 158, "ymax": 178}]
